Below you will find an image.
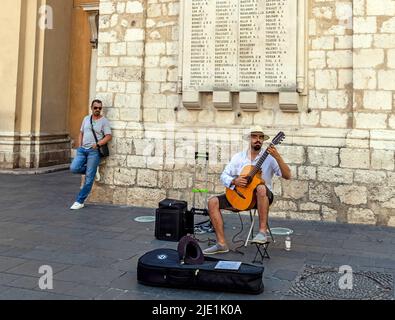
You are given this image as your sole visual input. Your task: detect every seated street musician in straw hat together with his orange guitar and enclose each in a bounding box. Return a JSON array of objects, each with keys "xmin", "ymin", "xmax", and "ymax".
[{"xmin": 203, "ymin": 126, "xmax": 291, "ymax": 255}]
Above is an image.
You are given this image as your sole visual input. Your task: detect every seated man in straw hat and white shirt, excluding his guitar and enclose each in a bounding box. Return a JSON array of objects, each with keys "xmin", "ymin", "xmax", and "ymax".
[{"xmin": 203, "ymin": 126, "xmax": 291, "ymax": 255}]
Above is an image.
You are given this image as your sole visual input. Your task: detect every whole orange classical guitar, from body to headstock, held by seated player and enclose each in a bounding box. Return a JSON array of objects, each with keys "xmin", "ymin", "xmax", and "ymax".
[{"xmin": 226, "ymin": 132, "xmax": 285, "ymax": 211}]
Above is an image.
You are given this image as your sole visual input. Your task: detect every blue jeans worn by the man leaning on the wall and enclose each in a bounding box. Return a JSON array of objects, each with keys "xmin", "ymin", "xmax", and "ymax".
[{"xmin": 70, "ymin": 147, "xmax": 100, "ymax": 204}]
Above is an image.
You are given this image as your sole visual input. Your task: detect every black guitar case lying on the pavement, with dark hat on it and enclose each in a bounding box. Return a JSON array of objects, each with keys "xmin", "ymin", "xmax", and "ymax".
[{"xmin": 137, "ymin": 236, "xmax": 264, "ymax": 294}]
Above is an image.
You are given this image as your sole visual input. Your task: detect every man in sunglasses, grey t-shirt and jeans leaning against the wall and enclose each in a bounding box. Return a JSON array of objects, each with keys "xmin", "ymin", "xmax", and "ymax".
[{"xmin": 70, "ymin": 100, "xmax": 112, "ymax": 210}]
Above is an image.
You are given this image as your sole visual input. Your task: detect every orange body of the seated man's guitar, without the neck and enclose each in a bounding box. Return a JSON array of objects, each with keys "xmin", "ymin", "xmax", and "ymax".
[{"xmin": 226, "ymin": 165, "xmax": 263, "ymax": 211}]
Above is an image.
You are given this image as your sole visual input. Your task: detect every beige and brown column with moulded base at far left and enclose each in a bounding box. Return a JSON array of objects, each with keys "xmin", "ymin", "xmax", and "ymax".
[{"xmin": 0, "ymin": 0, "xmax": 72, "ymax": 168}]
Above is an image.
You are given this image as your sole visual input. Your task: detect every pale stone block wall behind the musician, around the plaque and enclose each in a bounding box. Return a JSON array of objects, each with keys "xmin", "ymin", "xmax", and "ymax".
[{"xmin": 94, "ymin": 0, "xmax": 395, "ymax": 226}]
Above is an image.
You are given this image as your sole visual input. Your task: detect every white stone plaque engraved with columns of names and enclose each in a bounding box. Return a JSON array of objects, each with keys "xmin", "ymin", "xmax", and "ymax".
[{"xmin": 183, "ymin": 0, "xmax": 297, "ymax": 92}]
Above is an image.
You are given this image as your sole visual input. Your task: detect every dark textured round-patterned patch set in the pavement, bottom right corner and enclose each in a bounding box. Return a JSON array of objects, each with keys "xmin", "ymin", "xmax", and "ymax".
[{"xmin": 289, "ymin": 265, "xmax": 394, "ymax": 300}]
